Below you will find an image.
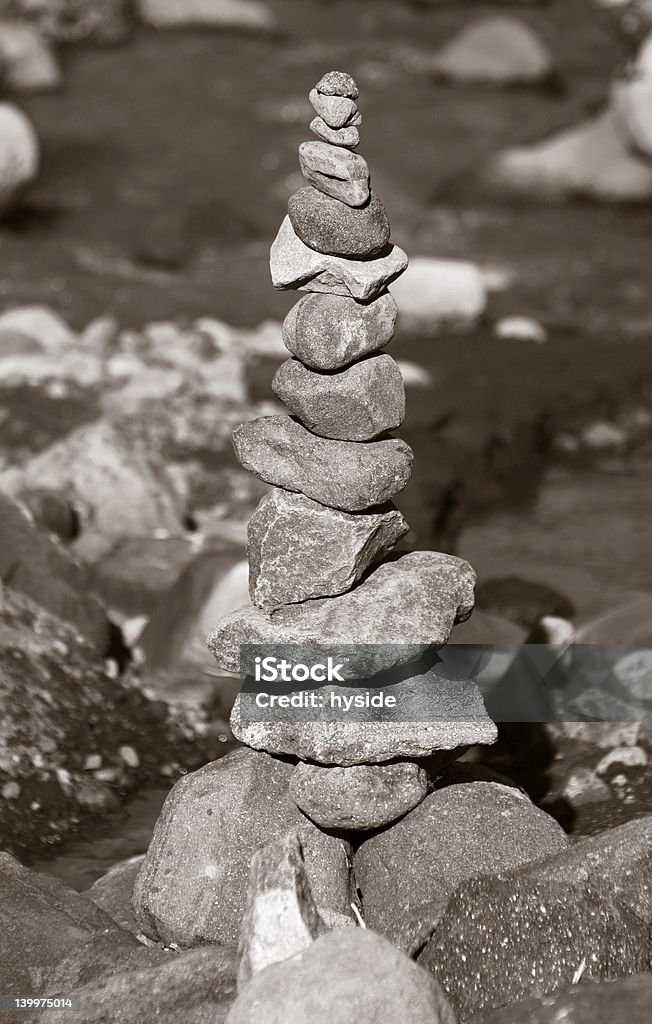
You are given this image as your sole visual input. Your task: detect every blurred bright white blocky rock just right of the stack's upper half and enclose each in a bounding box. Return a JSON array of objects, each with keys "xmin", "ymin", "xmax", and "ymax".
[{"xmin": 391, "ymin": 256, "xmax": 487, "ymax": 328}]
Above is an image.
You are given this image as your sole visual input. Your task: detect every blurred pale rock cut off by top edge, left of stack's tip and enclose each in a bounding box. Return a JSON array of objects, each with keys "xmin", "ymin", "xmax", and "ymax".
[{"xmin": 136, "ymin": 0, "xmax": 276, "ymax": 32}]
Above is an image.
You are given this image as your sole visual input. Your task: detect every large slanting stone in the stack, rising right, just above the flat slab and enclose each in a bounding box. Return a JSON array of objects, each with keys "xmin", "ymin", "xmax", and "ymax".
[{"xmin": 209, "ymin": 551, "xmax": 475, "ymax": 684}]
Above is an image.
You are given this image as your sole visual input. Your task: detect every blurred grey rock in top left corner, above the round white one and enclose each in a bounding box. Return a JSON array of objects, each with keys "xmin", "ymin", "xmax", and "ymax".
[{"xmin": 0, "ymin": 22, "xmax": 62, "ymax": 92}]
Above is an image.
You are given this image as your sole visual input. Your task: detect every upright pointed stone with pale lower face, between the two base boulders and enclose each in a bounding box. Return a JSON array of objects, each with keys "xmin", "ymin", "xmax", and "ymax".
[{"xmin": 237, "ymin": 831, "xmax": 329, "ymax": 989}]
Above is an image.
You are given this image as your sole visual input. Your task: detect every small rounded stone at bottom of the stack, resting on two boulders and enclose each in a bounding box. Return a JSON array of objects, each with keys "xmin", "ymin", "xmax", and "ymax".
[{"xmin": 290, "ymin": 761, "xmax": 428, "ymax": 830}]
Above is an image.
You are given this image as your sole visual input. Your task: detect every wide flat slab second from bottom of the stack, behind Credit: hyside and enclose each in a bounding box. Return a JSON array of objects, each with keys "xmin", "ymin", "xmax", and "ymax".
[{"xmin": 231, "ymin": 659, "xmax": 496, "ymax": 765}]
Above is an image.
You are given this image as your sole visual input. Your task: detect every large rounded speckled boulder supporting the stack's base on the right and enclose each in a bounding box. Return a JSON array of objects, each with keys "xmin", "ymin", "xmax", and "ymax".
[{"xmin": 355, "ymin": 771, "xmax": 568, "ymax": 941}]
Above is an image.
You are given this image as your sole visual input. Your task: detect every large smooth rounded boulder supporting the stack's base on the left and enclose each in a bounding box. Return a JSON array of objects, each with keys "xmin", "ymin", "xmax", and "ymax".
[{"xmin": 133, "ymin": 750, "xmax": 350, "ymax": 946}]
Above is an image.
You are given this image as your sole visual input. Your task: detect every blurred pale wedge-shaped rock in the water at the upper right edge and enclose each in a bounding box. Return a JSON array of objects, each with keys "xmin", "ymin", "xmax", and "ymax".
[{"xmin": 485, "ymin": 108, "xmax": 652, "ymax": 203}]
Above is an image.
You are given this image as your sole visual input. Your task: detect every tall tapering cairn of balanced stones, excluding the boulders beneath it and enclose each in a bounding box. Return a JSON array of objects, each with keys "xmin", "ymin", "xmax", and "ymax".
[{"xmin": 209, "ymin": 72, "xmax": 495, "ymax": 829}]
